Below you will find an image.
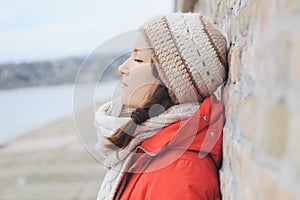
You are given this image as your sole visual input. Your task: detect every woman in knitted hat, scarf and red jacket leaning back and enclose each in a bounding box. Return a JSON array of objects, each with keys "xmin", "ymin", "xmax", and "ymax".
[{"xmin": 95, "ymin": 13, "xmax": 228, "ymax": 200}]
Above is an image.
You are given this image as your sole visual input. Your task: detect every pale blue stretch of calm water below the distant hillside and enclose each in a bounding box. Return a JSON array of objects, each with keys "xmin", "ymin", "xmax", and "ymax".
[{"xmin": 0, "ymin": 82, "xmax": 117, "ymax": 144}]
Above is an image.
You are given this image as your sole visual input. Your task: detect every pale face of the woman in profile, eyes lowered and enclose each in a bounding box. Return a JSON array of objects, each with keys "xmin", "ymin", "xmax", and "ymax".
[{"xmin": 118, "ymin": 34, "xmax": 159, "ymax": 108}]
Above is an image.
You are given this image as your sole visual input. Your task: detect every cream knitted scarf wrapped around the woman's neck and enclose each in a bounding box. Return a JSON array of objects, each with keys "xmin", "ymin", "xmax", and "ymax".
[{"xmin": 94, "ymin": 97, "xmax": 199, "ymax": 200}]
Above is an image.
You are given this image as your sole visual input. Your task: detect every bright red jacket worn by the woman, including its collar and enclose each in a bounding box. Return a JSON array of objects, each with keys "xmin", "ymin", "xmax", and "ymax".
[{"xmin": 115, "ymin": 95, "xmax": 224, "ymax": 200}]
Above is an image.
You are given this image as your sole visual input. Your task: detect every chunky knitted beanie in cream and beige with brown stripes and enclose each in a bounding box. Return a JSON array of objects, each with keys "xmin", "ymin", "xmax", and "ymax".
[{"xmin": 140, "ymin": 13, "xmax": 228, "ymax": 103}]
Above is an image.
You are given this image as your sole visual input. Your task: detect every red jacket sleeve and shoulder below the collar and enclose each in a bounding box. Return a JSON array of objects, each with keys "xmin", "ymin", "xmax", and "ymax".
[{"xmin": 145, "ymin": 157, "xmax": 220, "ymax": 200}]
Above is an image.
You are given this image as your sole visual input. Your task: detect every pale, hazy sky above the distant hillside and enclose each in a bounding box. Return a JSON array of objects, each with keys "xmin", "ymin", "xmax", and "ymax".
[{"xmin": 0, "ymin": 0, "xmax": 174, "ymax": 63}]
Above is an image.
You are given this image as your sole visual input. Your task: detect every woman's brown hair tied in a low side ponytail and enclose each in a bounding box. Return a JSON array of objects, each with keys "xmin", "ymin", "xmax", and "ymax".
[{"xmin": 106, "ymin": 62, "xmax": 174, "ymax": 150}]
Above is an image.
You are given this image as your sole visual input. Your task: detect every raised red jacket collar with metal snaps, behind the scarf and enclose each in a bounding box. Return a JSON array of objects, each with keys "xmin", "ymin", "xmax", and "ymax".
[{"xmin": 138, "ymin": 95, "xmax": 224, "ymax": 156}]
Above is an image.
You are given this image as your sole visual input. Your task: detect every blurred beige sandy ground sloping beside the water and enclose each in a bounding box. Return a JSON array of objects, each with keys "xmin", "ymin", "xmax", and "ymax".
[{"xmin": 0, "ymin": 107, "xmax": 105, "ymax": 200}]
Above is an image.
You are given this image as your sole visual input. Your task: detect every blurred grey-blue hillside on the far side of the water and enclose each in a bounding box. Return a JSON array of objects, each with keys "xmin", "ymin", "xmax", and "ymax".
[{"xmin": 0, "ymin": 54, "xmax": 128, "ymax": 90}]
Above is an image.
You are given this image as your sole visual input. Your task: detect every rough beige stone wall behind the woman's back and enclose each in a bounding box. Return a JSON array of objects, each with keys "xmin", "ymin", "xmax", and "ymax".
[{"xmin": 179, "ymin": 0, "xmax": 300, "ymax": 200}]
